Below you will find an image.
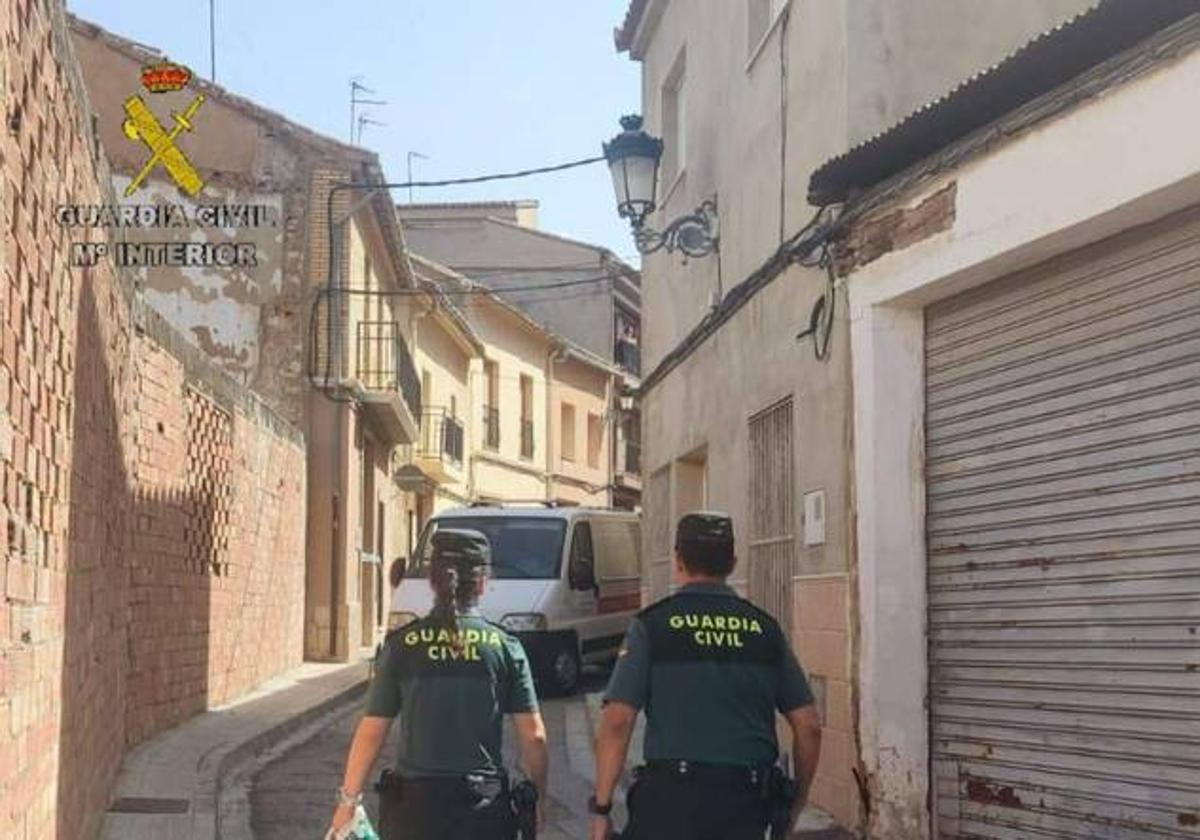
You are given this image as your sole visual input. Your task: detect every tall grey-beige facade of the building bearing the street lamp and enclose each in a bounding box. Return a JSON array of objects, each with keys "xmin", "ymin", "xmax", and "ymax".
[{"xmin": 618, "ymin": 0, "xmax": 1090, "ymax": 827}]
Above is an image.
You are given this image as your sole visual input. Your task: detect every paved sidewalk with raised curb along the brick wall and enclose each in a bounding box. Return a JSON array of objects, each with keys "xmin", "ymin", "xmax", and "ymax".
[{"xmin": 100, "ymin": 662, "xmax": 368, "ymax": 840}]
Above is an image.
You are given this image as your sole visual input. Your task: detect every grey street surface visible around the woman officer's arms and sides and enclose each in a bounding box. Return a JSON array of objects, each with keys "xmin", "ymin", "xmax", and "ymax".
[{"xmin": 251, "ymin": 674, "xmax": 624, "ymax": 840}]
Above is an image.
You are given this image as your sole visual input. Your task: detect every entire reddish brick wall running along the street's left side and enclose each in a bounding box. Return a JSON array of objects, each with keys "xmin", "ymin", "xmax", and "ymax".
[{"xmin": 0, "ymin": 0, "xmax": 305, "ymax": 840}]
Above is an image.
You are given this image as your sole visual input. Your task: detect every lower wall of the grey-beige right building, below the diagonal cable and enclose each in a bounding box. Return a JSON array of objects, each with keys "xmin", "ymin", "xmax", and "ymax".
[{"xmin": 642, "ymin": 258, "xmax": 859, "ymax": 826}]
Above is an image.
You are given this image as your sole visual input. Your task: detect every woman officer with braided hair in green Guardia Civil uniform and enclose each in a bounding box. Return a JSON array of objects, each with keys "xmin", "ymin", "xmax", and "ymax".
[{"xmin": 334, "ymin": 529, "xmax": 547, "ymax": 840}]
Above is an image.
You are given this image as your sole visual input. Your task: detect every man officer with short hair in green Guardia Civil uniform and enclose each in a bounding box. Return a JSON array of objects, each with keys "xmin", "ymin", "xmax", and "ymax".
[{"xmin": 588, "ymin": 512, "xmax": 821, "ymax": 840}]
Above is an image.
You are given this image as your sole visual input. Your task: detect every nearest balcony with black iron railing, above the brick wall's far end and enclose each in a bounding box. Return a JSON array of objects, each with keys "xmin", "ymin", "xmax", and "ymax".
[{"xmin": 353, "ymin": 320, "xmax": 421, "ymax": 444}]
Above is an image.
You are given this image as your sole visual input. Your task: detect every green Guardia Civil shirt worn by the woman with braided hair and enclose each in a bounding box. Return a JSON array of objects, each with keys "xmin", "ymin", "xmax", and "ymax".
[{"xmin": 366, "ymin": 612, "xmax": 538, "ymax": 778}]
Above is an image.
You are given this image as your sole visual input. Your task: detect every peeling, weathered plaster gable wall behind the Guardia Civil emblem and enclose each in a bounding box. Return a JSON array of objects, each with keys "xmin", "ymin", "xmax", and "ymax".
[{"xmin": 72, "ymin": 22, "xmax": 352, "ymax": 426}]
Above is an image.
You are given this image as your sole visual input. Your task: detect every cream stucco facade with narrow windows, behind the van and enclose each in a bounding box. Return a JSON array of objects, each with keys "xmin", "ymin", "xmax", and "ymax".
[{"xmin": 413, "ymin": 256, "xmax": 623, "ymax": 508}]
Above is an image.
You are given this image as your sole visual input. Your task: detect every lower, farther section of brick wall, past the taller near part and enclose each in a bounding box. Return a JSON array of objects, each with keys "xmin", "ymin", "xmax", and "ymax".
[{"xmin": 125, "ymin": 319, "xmax": 305, "ymax": 744}]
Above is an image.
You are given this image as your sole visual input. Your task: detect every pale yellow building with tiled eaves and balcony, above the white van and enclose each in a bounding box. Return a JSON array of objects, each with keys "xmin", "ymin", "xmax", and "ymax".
[{"xmin": 396, "ymin": 254, "xmax": 623, "ymax": 534}]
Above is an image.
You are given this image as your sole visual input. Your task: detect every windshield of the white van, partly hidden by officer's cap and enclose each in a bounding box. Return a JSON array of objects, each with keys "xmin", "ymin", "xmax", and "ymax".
[{"xmin": 407, "ymin": 516, "xmax": 566, "ymax": 580}]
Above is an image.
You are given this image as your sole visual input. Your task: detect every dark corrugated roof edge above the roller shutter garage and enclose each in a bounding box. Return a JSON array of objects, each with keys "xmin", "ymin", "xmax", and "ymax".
[{"xmin": 809, "ymin": 0, "xmax": 1200, "ymax": 206}]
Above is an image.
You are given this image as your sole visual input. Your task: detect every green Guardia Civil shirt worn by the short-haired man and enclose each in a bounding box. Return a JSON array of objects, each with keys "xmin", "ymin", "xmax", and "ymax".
[{"xmin": 605, "ymin": 583, "xmax": 812, "ymax": 766}]
